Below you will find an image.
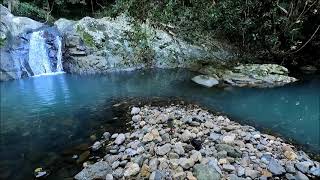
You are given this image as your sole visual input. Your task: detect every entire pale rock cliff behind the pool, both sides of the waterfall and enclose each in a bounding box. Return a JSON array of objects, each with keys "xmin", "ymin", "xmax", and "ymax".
[{"xmin": 0, "ymin": 5, "xmax": 235, "ymax": 81}]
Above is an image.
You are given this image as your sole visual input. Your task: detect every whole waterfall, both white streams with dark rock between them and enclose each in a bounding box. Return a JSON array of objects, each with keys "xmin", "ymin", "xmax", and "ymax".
[{"xmin": 28, "ymin": 30, "xmax": 63, "ymax": 76}]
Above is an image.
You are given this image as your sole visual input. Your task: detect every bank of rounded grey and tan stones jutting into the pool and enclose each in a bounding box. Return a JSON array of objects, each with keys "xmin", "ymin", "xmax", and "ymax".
[{"xmin": 75, "ymin": 105, "xmax": 320, "ymax": 180}]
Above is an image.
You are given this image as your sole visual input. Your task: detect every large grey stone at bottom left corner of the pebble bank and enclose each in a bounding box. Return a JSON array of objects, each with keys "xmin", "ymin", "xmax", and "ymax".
[{"xmin": 74, "ymin": 161, "xmax": 112, "ymax": 180}]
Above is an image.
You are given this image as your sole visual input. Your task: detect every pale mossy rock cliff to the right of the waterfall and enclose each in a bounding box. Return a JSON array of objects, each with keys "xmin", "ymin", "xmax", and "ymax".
[{"xmin": 55, "ymin": 16, "xmax": 234, "ymax": 74}]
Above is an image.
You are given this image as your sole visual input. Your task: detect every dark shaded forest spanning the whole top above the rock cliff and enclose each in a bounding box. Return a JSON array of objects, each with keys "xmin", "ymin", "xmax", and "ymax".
[{"xmin": 1, "ymin": 0, "xmax": 320, "ymax": 66}]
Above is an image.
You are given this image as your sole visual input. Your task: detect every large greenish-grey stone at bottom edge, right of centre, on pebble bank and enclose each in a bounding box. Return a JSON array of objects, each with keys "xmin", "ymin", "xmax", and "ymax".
[{"xmin": 193, "ymin": 164, "xmax": 220, "ymax": 180}]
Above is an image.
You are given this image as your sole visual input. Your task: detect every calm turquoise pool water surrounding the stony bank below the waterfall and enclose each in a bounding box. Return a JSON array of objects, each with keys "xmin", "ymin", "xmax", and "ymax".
[{"xmin": 0, "ymin": 70, "xmax": 320, "ymax": 179}]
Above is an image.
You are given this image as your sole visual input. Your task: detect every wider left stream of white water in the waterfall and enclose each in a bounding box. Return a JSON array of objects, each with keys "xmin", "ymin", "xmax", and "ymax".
[{"xmin": 29, "ymin": 31, "xmax": 52, "ymax": 75}]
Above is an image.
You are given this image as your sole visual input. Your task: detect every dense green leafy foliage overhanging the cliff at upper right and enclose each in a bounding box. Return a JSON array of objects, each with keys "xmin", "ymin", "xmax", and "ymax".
[{"xmin": 100, "ymin": 0, "xmax": 320, "ymax": 60}]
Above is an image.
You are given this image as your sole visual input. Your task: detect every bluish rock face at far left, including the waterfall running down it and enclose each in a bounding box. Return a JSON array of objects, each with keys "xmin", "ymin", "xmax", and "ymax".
[{"xmin": 0, "ymin": 5, "xmax": 62, "ymax": 81}]
